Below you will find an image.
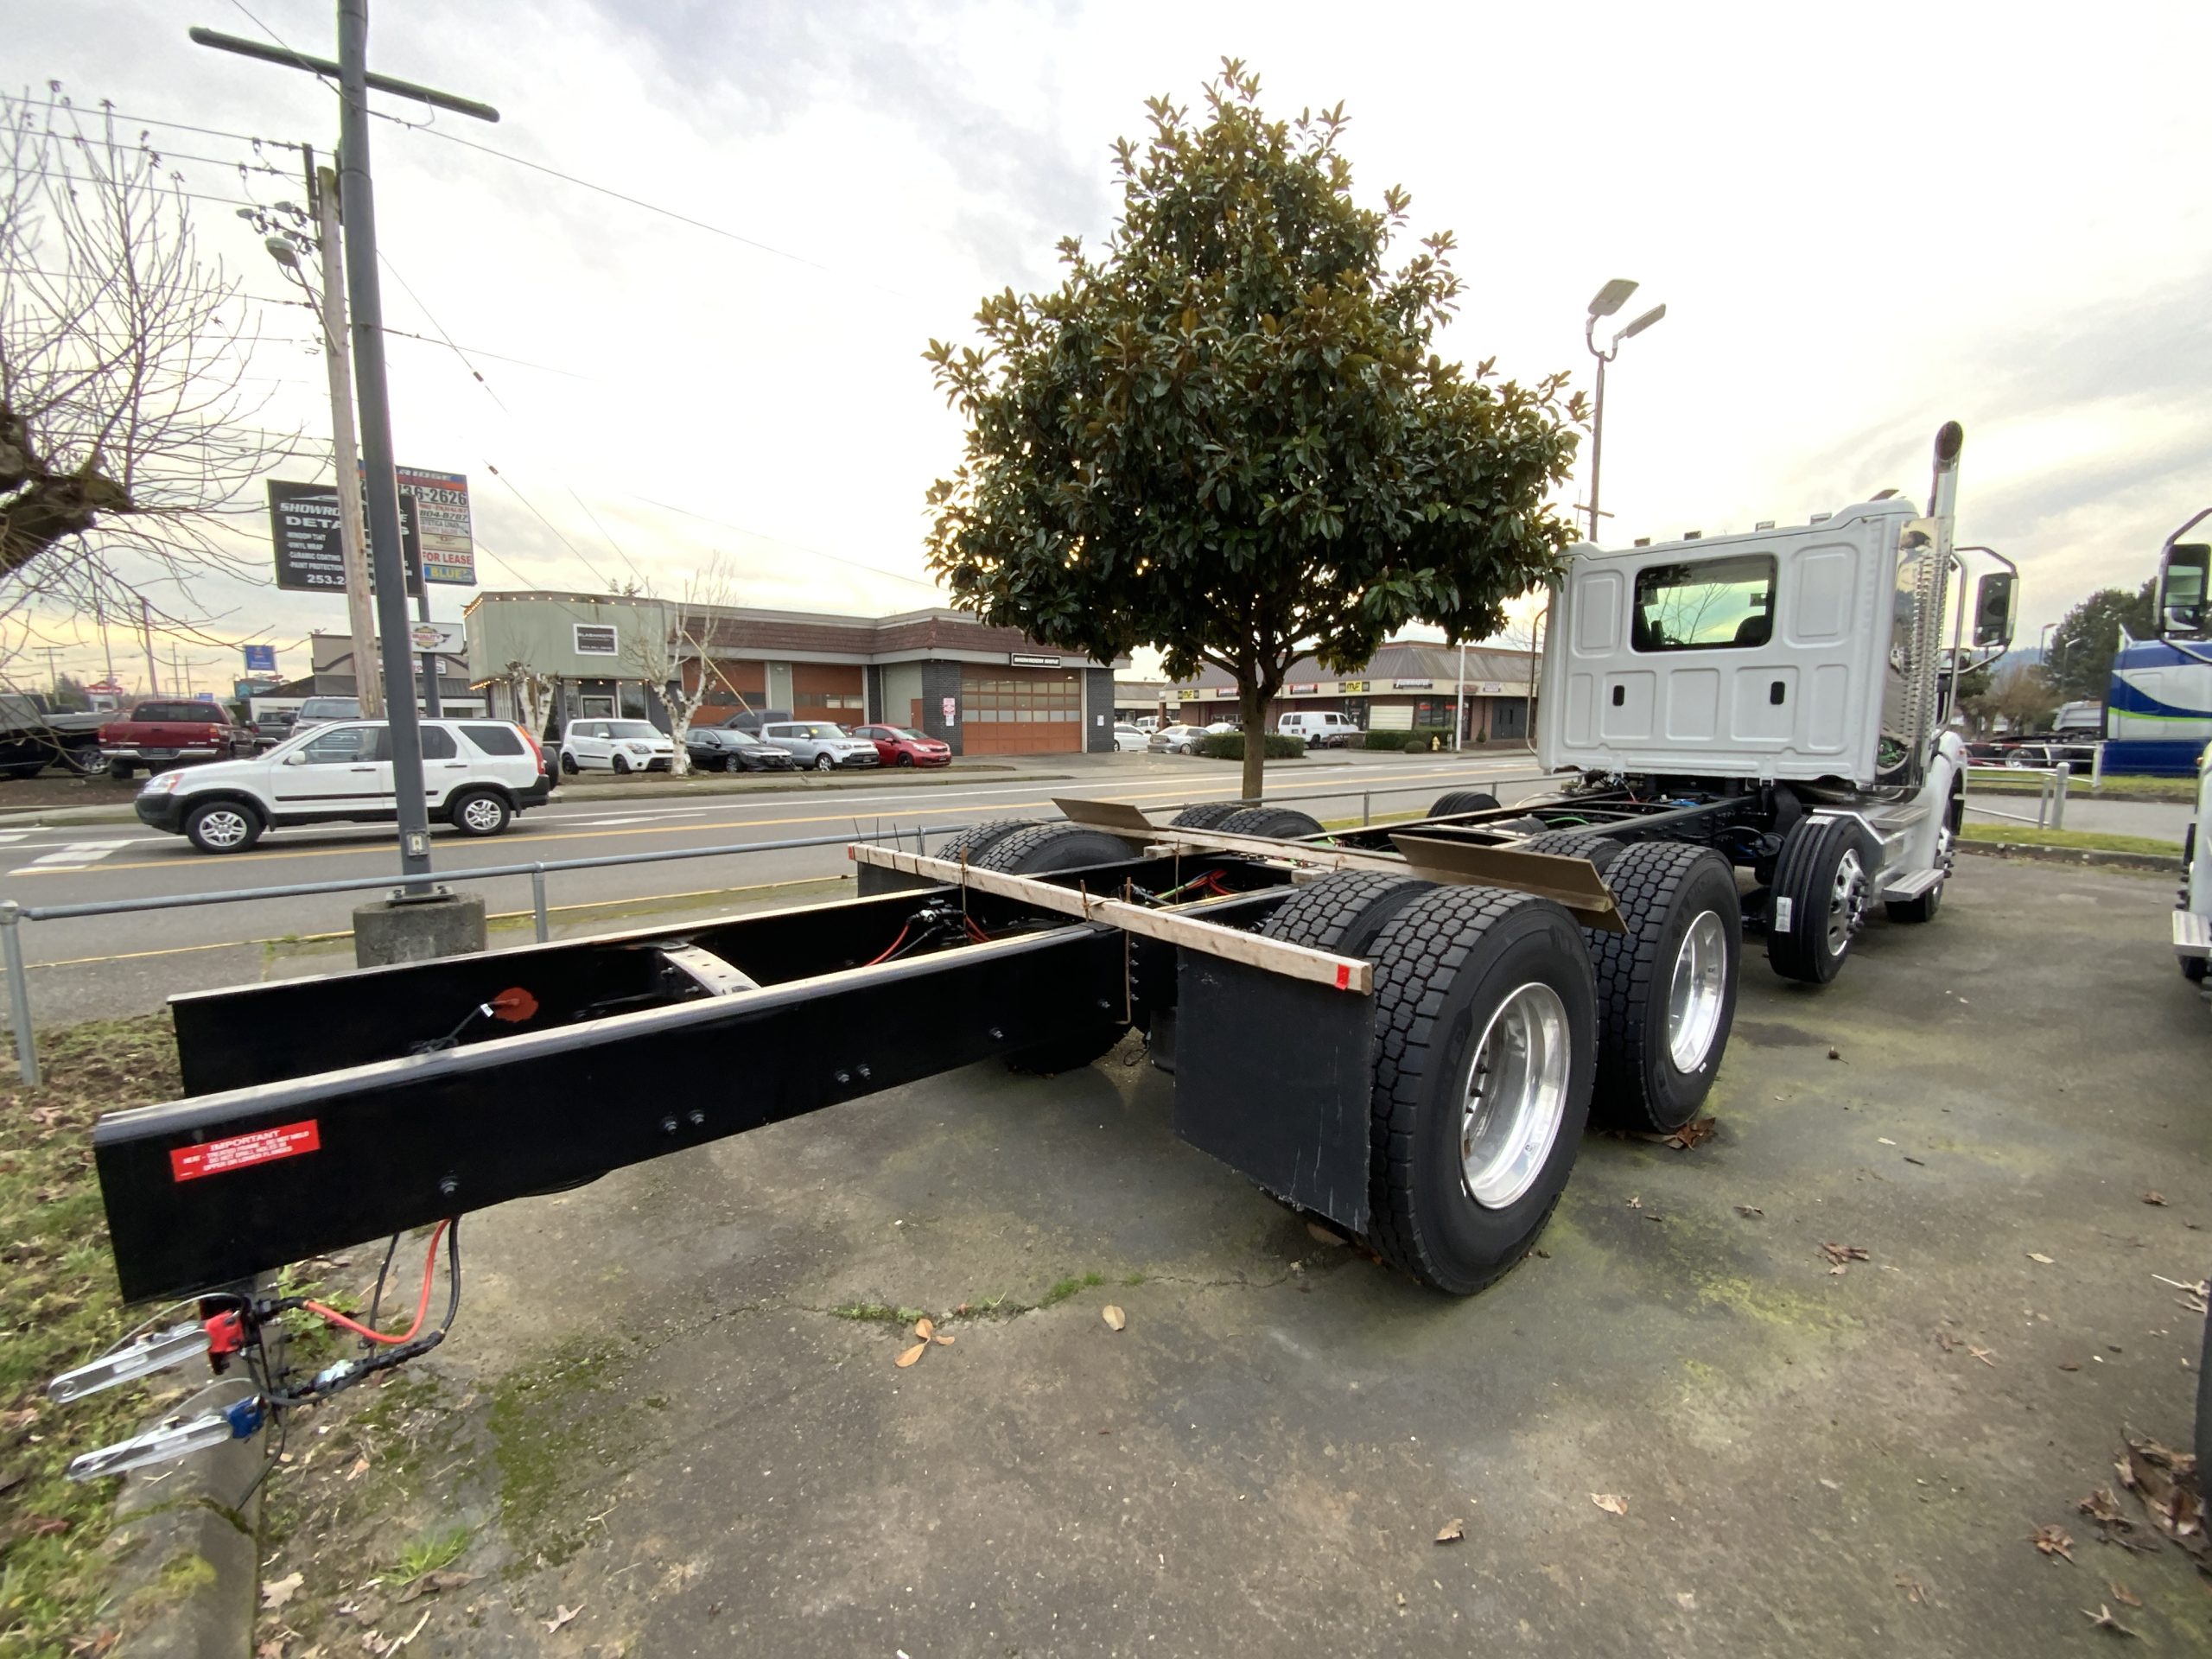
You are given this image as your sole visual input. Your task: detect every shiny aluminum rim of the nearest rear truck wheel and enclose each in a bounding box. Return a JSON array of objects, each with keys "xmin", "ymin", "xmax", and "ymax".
[{"xmin": 1460, "ymin": 980, "xmax": 1568, "ymax": 1210}]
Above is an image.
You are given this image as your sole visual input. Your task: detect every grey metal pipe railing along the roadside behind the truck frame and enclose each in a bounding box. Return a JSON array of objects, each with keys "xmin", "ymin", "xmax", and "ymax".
[{"xmin": 0, "ymin": 774, "xmax": 1551, "ymax": 1089}]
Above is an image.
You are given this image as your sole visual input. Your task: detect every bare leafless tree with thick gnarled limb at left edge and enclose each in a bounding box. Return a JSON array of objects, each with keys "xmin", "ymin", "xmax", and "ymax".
[{"xmin": 0, "ymin": 86, "xmax": 296, "ymax": 672}]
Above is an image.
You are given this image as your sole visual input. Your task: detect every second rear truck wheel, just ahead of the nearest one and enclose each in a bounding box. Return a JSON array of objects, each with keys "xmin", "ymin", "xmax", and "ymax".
[{"xmin": 1584, "ymin": 841, "xmax": 1743, "ymax": 1135}]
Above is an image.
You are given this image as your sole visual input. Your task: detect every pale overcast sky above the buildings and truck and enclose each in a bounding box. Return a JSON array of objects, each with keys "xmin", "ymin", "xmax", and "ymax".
[{"xmin": 9, "ymin": 0, "xmax": 2212, "ymax": 686}]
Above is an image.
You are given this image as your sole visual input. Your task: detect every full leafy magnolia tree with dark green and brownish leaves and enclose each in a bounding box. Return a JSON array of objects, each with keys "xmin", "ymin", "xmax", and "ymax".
[{"xmin": 927, "ymin": 60, "xmax": 1581, "ymax": 798}]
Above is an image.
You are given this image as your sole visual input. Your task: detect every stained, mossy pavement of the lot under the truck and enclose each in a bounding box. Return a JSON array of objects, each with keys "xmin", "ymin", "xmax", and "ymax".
[{"xmin": 265, "ymin": 861, "xmax": 2212, "ymax": 1659}]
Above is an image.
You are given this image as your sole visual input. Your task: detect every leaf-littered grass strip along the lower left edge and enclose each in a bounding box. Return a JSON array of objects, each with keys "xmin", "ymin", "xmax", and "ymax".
[{"xmin": 0, "ymin": 1013, "xmax": 188, "ymax": 1655}]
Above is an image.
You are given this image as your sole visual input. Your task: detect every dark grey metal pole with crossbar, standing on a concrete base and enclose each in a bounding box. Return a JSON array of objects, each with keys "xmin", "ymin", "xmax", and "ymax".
[{"xmin": 190, "ymin": 16, "xmax": 500, "ymax": 898}]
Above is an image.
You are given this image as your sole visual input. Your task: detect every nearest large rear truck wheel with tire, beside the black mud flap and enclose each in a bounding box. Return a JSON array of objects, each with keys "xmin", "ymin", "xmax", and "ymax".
[{"xmin": 1367, "ymin": 887, "xmax": 1597, "ymax": 1296}]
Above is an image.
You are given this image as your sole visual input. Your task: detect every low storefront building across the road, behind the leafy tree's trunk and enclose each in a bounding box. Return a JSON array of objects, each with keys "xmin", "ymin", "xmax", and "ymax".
[{"xmin": 1166, "ymin": 639, "xmax": 1535, "ymax": 743}]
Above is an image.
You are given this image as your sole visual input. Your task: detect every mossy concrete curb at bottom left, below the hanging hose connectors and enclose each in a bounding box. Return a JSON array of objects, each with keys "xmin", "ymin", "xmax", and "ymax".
[{"xmin": 104, "ymin": 1431, "xmax": 268, "ymax": 1659}]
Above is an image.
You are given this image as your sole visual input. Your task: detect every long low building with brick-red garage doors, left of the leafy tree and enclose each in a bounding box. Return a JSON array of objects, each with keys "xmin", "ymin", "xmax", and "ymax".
[{"xmin": 467, "ymin": 593, "xmax": 1113, "ymax": 754}]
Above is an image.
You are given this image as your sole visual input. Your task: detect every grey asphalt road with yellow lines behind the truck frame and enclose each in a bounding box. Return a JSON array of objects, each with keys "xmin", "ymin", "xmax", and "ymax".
[{"xmin": 0, "ymin": 754, "xmax": 1566, "ymax": 1027}]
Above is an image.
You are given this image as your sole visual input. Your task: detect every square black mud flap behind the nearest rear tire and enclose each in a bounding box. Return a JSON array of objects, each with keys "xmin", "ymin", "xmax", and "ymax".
[{"xmin": 1174, "ymin": 951, "xmax": 1376, "ymax": 1232}]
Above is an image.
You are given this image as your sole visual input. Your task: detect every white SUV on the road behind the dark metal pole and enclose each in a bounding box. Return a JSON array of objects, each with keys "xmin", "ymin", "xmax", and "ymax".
[{"xmin": 137, "ymin": 719, "xmax": 553, "ymax": 852}]
